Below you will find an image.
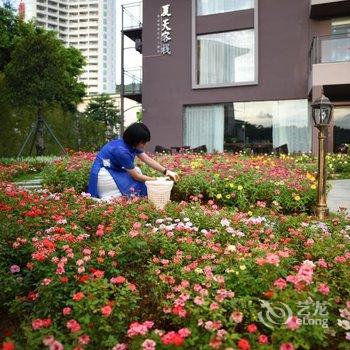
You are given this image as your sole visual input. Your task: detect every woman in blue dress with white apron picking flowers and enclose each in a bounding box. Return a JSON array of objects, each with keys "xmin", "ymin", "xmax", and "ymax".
[{"xmin": 88, "ymin": 123, "xmax": 178, "ymax": 199}]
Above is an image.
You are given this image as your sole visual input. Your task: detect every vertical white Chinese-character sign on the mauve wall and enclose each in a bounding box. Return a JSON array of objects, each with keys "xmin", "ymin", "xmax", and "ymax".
[{"xmin": 157, "ymin": 4, "xmax": 172, "ymax": 55}]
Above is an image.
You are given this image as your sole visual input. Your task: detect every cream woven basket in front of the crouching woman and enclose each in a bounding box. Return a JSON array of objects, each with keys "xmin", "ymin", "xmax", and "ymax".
[{"xmin": 146, "ymin": 178, "xmax": 174, "ymax": 209}]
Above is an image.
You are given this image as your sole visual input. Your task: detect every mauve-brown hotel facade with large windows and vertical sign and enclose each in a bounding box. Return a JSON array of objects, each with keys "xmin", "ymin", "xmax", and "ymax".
[{"xmin": 137, "ymin": 0, "xmax": 350, "ymax": 153}]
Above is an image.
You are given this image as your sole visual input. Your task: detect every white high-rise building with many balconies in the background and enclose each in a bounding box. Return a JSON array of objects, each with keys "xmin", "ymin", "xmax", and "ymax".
[{"xmin": 22, "ymin": 0, "xmax": 116, "ymax": 95}]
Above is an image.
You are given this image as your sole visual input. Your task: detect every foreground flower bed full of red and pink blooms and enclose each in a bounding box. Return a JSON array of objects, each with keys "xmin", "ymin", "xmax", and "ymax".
[{"xmin": 0, "ymin": 183, "xmax": 350, "ymax": 350}]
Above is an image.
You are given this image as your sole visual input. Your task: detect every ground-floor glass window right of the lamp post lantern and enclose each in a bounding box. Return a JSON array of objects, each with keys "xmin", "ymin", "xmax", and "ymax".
[{"xmin": 333, "ymin": 106, "xmax": 350, "ymax": 152}]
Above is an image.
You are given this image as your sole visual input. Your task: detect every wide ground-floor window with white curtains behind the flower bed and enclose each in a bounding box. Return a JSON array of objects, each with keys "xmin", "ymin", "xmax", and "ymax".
[{"xmin": 183, "ymin": 100, "xmax": 311, "ymax": 153}]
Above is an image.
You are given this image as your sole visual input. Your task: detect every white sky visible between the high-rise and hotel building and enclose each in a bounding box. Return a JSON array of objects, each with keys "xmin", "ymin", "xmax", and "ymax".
[{"xmin": 0, "ymin": 0, "xmax": 142, "ymax": 84}]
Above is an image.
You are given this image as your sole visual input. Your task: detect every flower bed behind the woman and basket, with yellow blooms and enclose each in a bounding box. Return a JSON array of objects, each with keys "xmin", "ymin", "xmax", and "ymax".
[{"xmin": 43, "ymin": 153, "xmax": 316, "ymax": 213}]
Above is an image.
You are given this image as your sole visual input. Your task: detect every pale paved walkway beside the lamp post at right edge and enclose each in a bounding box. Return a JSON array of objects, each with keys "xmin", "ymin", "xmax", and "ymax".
[{"xmin": 327, "ymin": 180, "xmax": 350, "ymax": 214}]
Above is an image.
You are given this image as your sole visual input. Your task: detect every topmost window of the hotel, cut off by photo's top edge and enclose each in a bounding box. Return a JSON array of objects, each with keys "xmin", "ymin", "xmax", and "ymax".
[{"xmin": 197, "ymin": 0, "xmax": 254, "ymax": 16}]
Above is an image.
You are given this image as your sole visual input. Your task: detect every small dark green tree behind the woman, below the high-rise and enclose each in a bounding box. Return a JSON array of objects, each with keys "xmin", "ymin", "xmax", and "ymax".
[{"xmin": 85, "ymin": 94, "xmax": 120, "ymax": 140}]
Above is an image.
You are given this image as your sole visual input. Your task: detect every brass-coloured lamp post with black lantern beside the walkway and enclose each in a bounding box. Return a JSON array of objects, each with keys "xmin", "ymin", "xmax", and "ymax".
[{"xmin": 311, "ymin": 95, "xmax": 333, "ymax": 220}]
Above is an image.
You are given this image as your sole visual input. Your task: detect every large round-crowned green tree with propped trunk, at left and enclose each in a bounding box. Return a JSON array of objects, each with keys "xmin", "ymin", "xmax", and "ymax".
[{"xmin": 4, "ymin": 26, "xmax": 85, "ymax": 155}]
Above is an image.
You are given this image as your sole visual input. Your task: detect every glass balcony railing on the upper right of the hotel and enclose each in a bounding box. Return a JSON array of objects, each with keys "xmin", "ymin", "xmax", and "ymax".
[{"xmin": 309, "ymin": 34, "xmax": 350, "ymax": 66}]
